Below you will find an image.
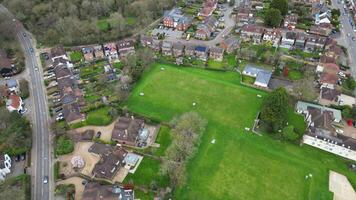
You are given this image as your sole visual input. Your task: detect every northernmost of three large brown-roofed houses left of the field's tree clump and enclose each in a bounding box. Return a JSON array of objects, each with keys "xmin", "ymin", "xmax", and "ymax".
[{"xmin": 112, "ymin": 117, "xmax": 149, "ymax": 147}]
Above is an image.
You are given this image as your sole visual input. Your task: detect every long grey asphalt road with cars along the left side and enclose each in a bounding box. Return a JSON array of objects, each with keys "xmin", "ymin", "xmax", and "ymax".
[{"xmin": 0, "ymin": 4, "xmax": 53, "ymax": 200}]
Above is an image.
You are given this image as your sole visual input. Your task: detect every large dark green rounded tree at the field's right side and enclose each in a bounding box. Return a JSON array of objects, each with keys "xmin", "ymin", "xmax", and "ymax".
[{"xmin": 261, "ymin": 88, "xmax": 289, "ymax": 132}]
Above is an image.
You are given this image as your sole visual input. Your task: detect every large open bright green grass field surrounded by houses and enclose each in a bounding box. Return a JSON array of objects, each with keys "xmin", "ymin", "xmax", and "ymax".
[{"xmin": 126, "ymin": 64, "xmax": 356, "ymax": 200}]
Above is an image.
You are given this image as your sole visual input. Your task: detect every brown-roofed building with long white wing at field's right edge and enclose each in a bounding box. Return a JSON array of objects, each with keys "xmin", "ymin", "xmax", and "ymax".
[{"xmin": 296, "ymin": 101, "xmax": 356, "ymax": 161}]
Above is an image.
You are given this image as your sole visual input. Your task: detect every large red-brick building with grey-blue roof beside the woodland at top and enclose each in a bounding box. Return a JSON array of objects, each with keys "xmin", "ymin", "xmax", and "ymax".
[{"xmin": 163, "ymin": 8, "xmax": 192, "ymax": 31}]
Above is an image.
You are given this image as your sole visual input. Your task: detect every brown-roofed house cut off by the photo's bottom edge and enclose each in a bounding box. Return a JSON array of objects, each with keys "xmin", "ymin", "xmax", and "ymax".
[{"xmin": 81, "ymin": 182, "xmax": 135, "ymax": 200}]
